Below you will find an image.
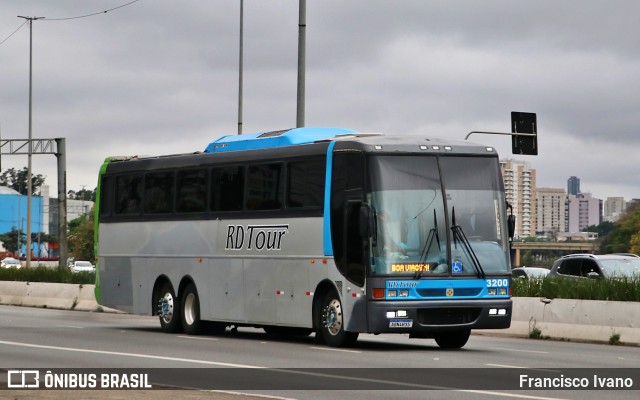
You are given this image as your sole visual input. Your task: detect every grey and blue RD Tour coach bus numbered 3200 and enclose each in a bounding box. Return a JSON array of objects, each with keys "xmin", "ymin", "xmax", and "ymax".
[{"xmin": 95, "ymin": 128, "xmax": 513, "ymax": 348}]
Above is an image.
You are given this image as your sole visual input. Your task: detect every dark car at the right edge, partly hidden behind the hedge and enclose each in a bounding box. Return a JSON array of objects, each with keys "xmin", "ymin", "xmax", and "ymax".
[{"xmin": 549, "ymin": 254, "xmax": 640, "ymax": 278}]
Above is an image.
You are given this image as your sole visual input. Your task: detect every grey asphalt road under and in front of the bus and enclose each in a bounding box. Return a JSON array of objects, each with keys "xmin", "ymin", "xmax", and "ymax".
[{"xmin": 0, "ymin": 306, "xmax": 640, "ymax": 400}]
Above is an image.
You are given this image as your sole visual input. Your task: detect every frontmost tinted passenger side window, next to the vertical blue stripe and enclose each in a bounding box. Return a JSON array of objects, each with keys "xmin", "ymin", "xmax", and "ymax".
[{"xmin": 287, "ymin": 158, "xmax": 325, "ymax": 208}]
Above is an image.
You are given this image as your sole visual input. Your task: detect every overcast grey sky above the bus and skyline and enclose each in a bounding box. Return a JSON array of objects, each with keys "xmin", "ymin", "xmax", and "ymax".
[{"xmin": 0, "ymin": 0, "xmax": 640, "ymax": 200}]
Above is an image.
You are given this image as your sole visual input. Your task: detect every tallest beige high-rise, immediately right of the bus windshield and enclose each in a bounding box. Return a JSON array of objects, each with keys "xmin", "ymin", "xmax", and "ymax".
[{"xmin": 500, "ymin": 160, "xmax": 536, "ymax": 237}]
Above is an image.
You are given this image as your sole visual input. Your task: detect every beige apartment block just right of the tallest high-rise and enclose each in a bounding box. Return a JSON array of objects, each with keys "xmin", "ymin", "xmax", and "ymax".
[{"xmin": 536, "ymin": 188, "xmax": 567, "ymax": 237}]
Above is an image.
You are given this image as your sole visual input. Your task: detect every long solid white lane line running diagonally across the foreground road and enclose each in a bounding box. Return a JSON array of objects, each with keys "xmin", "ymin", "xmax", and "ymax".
[{"xmin": 0, "ymin": 340, "xmax": 566, "ymax": 400}]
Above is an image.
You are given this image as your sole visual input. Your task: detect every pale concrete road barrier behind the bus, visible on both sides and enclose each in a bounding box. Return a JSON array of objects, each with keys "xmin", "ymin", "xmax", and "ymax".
[{"xmin": 0, "ymin": 281, "xmax": 640, "ymax": 346}]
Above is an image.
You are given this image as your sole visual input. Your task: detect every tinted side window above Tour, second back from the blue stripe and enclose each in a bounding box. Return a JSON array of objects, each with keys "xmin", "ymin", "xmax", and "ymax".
[{"xmin": 246, "ymin": 164, "xmax": 284, "ymax": 210}]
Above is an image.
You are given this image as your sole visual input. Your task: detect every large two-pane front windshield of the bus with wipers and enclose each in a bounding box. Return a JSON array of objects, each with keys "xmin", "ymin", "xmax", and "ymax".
[{"xmin": 368, "ymin": 155, "xmax": 509, "ymax": 278}]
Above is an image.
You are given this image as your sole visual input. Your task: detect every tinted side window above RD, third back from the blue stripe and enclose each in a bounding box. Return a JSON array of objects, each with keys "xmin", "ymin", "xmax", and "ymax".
[{"xmin": 211, "ymin": 166, "xmax": 244, "ymax": 211}]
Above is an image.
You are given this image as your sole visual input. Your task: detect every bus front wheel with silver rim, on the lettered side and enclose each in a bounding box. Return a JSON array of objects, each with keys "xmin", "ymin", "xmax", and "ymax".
[{"xmin": 318, "ymin": 291, "xmax": 358, "ymax": 347}]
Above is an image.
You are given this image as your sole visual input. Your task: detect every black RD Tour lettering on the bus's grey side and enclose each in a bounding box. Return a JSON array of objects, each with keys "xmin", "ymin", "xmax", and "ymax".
[{"xmin": 225, "ymin": 224, "xmax": 289, "ymax": 251}]
